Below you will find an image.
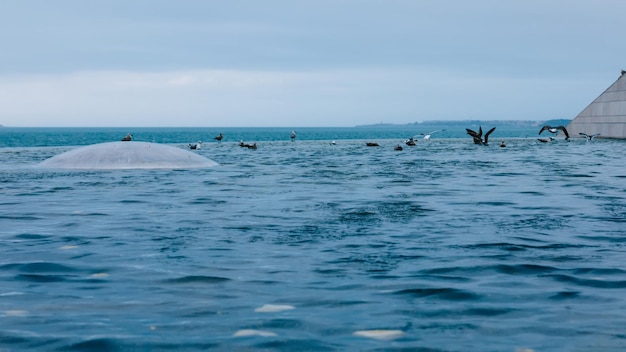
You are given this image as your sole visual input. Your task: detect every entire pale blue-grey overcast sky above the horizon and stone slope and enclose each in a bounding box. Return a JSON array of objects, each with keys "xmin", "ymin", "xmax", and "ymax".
[{"xmin": 0, "ymin": 0, "xmax": 626, "ymax": 127}]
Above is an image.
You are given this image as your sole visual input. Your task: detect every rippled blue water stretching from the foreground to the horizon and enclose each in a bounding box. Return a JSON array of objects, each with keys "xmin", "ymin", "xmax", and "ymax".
[{"xmin": 0, "ymin": 126, "xmax": 626, "ymax": 352}]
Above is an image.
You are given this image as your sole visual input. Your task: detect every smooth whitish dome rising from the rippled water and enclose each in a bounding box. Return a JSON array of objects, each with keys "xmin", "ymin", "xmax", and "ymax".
[{"xmin": 39, "ymin": 142, "xmax": 218, "ymax": 170}]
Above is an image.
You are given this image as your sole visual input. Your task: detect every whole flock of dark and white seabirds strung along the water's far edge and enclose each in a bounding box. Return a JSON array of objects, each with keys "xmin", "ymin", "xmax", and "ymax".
[{"xmin": 122, "ymin": 125, "xmax": 600, "ymax": 150}]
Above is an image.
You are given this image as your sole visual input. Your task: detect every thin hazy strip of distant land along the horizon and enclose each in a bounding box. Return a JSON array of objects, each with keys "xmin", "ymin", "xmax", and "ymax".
[{"xmin": 355, "ymin": 119, "xmax": 572, "ymax": 128}]
